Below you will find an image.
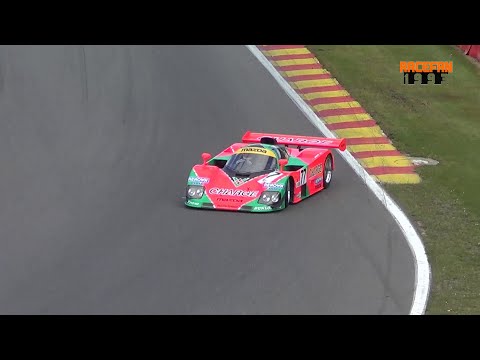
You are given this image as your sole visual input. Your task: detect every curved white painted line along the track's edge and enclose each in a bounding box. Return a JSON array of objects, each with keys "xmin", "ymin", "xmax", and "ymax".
[{"xmin": 246, "ymin": 45, "xmax": 431, "ymax": 315}]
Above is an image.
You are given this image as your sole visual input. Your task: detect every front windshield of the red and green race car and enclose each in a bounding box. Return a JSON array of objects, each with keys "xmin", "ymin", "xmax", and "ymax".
[{"xmin": 225, "ymin": 153, "xmax": 277, "ymax": 176}]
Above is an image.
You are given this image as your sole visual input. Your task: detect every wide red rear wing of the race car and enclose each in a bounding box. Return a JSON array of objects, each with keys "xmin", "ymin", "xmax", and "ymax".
[{"xmin": 242, "ymin": 131, "xmax": 347, "ymax": 151}]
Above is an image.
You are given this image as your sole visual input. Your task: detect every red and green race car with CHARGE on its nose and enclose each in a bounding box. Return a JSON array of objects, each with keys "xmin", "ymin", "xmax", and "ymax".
[{"xmin": 185, "ymin": 131, "xmax": 346, "ymax": 213}]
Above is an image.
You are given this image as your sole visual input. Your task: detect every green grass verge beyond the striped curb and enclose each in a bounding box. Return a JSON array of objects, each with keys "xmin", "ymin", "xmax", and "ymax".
[{"xmin": 308, "ymin": 45, "xmax": 480, "ymax": 314}]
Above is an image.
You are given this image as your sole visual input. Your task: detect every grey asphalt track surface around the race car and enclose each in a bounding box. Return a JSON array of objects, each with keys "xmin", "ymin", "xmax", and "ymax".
[{"xmin": 0, "ymin": 46, "xmax": 415, "ymax": 314}]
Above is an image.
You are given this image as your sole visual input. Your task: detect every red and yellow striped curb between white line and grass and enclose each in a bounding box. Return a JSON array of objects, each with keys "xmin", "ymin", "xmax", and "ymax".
[{"xmin": 257, "ymin": 45, "xmax": 421, "ymax": 184}]
